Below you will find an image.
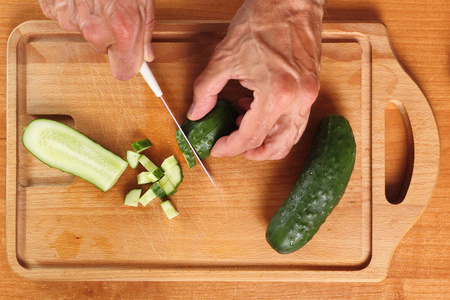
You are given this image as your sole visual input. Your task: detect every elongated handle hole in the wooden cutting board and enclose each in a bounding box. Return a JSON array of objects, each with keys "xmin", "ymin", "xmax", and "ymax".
[{"xmin": 384, "ymin": 100, "xmax": 414, "ymax": 204}]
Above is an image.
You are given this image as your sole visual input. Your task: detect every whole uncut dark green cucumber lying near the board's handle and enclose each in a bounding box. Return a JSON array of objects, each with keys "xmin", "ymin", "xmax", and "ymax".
[{"xmin": 266, "ymin": 114, "xmax": 356, "ymax": 254}]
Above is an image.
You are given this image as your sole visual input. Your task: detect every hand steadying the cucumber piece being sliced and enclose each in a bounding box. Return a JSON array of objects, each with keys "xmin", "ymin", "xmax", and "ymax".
[{"xmin": 188, "ymin": 0, "xmax": 323, "ymax": 160}]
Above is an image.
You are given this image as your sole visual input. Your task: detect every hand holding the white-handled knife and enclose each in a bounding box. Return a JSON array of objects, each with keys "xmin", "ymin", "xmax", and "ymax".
[{"xmin": 39, "ymin": 0, "xmax": 155, "ymax": 80}]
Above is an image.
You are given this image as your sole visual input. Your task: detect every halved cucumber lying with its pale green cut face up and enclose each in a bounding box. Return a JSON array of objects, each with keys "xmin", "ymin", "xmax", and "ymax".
[{"xmin": 22, "ymin": 119, "xmax": 128, "ymax": 192}]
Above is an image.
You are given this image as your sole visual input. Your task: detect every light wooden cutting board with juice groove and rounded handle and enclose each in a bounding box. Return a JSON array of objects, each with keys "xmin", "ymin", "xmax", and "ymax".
[{"xmin": 6, "ymin": 21, "xmax": 440, "ymax": 281}]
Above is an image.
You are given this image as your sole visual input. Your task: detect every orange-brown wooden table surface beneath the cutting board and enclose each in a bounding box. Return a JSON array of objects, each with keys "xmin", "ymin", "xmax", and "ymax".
[{"xmin": 0, "ymin": 0, "xmax": 450, "ymax": 299}]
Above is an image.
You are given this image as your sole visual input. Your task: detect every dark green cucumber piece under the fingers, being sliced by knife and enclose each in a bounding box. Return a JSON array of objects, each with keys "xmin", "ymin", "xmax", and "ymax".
[{"xmin": 175, "ymin": 99, "xmax": 238, "ymax": 168}]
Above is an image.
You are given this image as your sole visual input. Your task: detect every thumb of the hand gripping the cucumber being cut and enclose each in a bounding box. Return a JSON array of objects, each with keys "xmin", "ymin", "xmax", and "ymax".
[{"xmin": 188, "ymin": 59, "xmax": 231, "ymax": 121}]
